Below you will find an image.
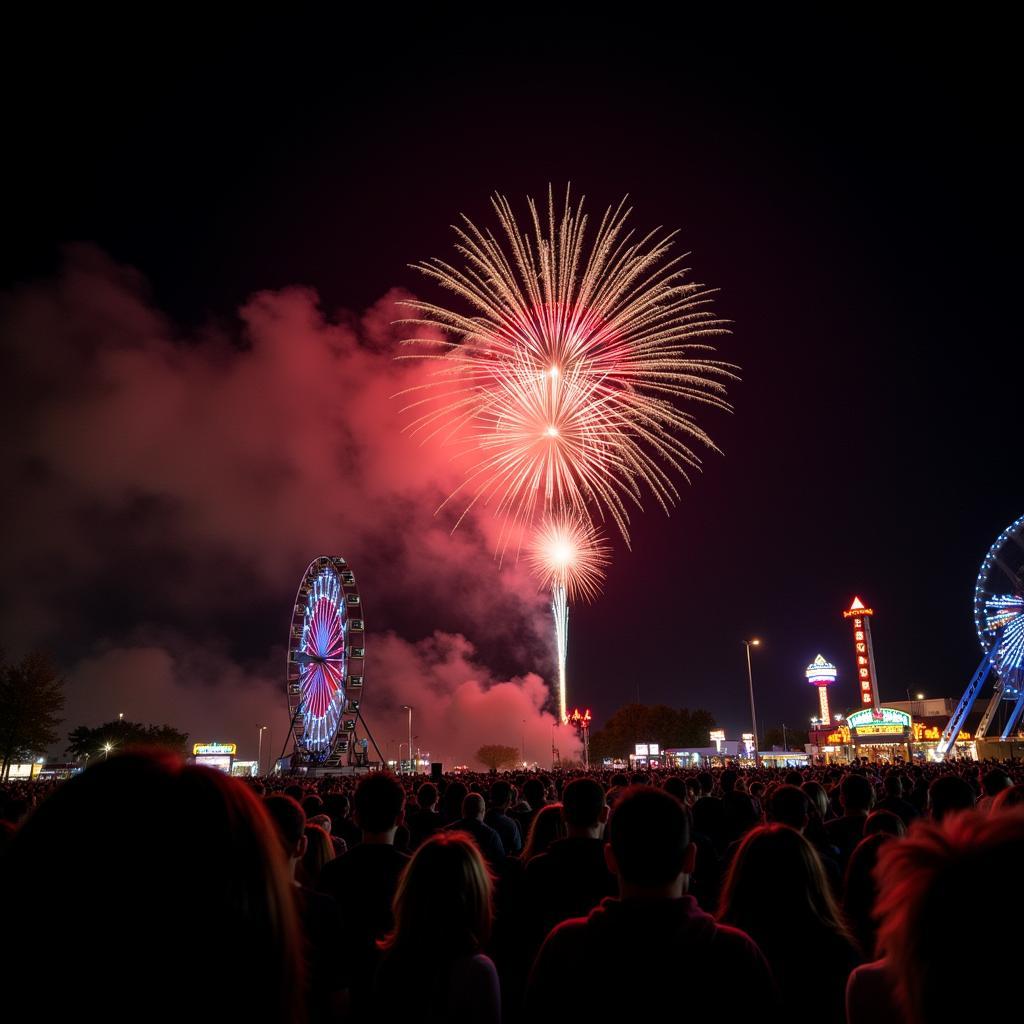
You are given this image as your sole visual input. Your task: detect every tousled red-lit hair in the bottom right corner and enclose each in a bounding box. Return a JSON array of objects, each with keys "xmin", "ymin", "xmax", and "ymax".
[{"xmin": 876, "ymin": 809, "xmax": 1024, "ymax": 1024}]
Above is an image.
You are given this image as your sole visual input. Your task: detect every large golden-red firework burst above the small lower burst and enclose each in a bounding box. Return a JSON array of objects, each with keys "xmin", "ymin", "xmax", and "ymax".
[{"xmin": 391, "ymin": 188, "xmax": 736, "ymax": 544}]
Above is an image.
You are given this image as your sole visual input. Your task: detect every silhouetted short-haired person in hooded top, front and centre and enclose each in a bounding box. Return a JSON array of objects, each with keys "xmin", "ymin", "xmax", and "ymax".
[{"xmin": 525, "ymin": 786, "xmax": 778, "ymax": 1024}]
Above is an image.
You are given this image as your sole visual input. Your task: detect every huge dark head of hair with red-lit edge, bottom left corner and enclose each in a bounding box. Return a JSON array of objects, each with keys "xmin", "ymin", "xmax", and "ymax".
[{"xmin": 0, "ymin": 750, "xmax": 305, "ymax": 1021}]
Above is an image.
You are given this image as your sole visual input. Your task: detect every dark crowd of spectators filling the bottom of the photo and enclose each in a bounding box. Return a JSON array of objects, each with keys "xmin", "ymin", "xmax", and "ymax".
[{"xmin": 0, "ymin": 751, "xmax": 1024, "ymax": 1024}]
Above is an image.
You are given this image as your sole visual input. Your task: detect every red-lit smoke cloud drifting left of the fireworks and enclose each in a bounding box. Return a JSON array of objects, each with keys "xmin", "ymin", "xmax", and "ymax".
[{"xmin": 0, "ymin": 246, "xmax": 575, "ymax": 764}]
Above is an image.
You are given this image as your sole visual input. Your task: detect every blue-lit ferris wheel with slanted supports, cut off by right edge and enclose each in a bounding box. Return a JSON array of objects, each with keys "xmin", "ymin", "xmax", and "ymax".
[{"xmin": 936, "ymin": 516, "xmax": 1024, "ymax": 758}]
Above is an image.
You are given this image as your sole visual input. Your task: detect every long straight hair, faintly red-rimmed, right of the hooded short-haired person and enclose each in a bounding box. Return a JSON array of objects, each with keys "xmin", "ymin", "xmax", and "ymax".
[{"xmin": 718, "ymin": 824, "xmax": 848, "ymax": 946}]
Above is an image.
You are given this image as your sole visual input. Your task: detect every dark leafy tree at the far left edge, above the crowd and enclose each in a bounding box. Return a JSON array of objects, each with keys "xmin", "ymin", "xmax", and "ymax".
[{"xmin": 0, "ymin": 651, "xmax": 66, "ymax": 779}]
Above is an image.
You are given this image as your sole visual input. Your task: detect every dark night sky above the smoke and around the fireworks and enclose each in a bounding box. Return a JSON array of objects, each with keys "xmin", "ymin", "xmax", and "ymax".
[{"xmin": 2, "ymin": 15, "xmax": 1024, "ymax": 757}]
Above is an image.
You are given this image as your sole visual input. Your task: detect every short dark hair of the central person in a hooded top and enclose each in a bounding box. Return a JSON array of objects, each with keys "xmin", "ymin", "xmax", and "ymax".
[{"xmin": 608, "ymin": 785, "xmax": 690, "ymax": 887}]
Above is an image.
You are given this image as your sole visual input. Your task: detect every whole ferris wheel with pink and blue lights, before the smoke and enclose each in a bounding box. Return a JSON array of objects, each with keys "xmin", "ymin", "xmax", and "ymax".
[{"xmin": 287, "ymin": 555, "xmax": 366, "ymax": 767}]
